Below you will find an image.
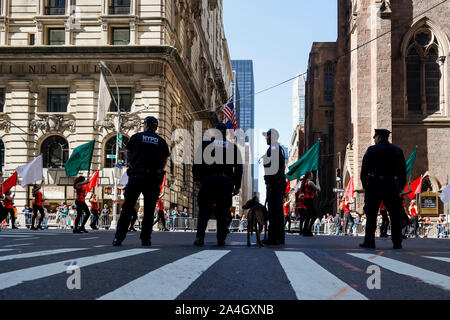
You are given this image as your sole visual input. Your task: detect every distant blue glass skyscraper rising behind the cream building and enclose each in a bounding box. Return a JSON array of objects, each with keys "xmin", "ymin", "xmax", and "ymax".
[{"xmin": 231, "ymin": 60, "xmax": 258, "ymax": 192}]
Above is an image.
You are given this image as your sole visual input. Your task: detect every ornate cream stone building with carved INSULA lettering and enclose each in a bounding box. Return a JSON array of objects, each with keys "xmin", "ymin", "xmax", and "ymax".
[{"xmin": 0, "ymin": 0, "xmax": 232, "ymax": 212}]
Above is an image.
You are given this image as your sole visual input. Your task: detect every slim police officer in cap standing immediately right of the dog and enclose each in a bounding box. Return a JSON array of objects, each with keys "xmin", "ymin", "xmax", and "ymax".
[{"xmin": 263, "ymin": 129, "xmax": 287, "ymax": 245}]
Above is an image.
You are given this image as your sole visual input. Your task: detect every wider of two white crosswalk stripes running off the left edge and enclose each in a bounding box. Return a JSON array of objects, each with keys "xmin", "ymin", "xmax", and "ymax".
[{"xmin": 0, "ymin": 249, "xmax": 157, "ymax": 290}]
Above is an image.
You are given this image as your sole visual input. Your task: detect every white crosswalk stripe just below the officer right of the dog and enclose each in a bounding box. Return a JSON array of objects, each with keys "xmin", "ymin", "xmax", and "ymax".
[{"xmin": 275, "ymin": 251, "xmax": 367, "ymax": 300}]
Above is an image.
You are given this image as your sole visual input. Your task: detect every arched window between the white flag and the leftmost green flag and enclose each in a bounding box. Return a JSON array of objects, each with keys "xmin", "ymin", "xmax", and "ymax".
[{"xmin": 41, "ymin": 136, "xmax": 69, "ymax": 168}]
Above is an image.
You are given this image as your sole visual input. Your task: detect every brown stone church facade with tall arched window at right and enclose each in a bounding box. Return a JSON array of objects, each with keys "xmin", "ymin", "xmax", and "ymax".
[{"xmin": 308, "ymin": 0, "xmax": 450, "ymax": 213}]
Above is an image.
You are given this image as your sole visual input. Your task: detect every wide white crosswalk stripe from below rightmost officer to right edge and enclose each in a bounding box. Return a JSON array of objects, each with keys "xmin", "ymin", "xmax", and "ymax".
[{"xmin": 349, "ymin": 253, "xmax": 450, "ymax": 290}]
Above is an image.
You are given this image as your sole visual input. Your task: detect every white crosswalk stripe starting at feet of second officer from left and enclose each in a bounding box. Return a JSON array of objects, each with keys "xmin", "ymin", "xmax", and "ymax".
[{"xmin": 99, "ymin": 250, "xmax": 230, "ymax": 300}]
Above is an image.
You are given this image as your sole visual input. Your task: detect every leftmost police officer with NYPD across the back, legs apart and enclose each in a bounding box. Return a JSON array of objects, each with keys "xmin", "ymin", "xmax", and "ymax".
[{"xmin": 113, "ymin": 117, "xmax": 170, "ymax": 246}]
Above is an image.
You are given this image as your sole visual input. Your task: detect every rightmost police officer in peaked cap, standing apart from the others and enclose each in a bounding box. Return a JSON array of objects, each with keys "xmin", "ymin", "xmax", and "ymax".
[{"xmin": 360, "ymin": 129, "xmax": 406, "ymax": 249}]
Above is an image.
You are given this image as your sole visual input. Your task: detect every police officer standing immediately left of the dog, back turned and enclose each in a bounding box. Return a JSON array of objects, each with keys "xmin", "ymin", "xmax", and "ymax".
[{"xmin": 192, "ymin": 123, "xmax": 242, "ymax": 246}]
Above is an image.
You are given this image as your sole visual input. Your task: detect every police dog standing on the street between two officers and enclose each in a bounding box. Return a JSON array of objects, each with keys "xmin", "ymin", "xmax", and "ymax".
[{"xmin": 242, "ymin": 197, "xmax": 268, "ymax": 247}]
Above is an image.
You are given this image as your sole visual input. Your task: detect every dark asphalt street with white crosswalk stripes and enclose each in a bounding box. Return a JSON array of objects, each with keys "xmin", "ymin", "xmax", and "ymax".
[{"xmin": 0, "ymin": 229, "xmax": 450, "ymax": 300}]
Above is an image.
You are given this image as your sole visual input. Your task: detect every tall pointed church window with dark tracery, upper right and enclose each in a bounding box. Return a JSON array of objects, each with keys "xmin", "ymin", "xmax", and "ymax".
[{"xmin": 405, "ymin": 28, "xmax": 442, "ymax": 113}]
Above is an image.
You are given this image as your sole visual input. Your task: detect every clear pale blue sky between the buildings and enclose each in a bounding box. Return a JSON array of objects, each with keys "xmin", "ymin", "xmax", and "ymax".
[{"xmin": 223, "ymin": 0, "xmax": 337, "ymax": 201}]
